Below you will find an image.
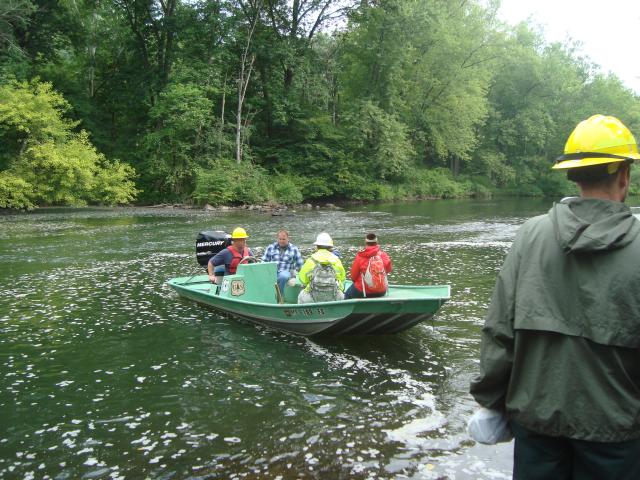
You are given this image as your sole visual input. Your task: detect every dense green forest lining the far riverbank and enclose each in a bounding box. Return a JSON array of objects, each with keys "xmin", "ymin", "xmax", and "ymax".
[{"xmin": 0, "ymin": 0, "xmax": 640, "ymax": 208}]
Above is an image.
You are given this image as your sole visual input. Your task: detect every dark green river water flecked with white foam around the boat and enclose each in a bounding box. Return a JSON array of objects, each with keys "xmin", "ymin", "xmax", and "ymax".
[{"xmin": 0, "ymin": 199, "xmax": 596, "ymax": 479}]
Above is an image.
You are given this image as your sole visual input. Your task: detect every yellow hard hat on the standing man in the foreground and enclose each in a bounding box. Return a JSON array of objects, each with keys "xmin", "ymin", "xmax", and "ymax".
[{"xmin": 552, "ymin": 115, "xmax": 640, "ymax": 171}]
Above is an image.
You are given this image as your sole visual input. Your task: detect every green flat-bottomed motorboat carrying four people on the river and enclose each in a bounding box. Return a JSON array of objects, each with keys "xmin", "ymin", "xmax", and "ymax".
[{"xmin": 168, "ymin": 263, "xmax": 450, "ymax": 336}]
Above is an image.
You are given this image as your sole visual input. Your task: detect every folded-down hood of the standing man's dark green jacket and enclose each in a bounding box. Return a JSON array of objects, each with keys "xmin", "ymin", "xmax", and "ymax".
[{"xmin": 549, "ymin": 197, "xmax": 640, "ymax": 253}]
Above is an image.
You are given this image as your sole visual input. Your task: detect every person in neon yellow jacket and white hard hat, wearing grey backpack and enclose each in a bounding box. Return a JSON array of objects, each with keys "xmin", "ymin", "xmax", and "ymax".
[{"xmin": 298, "ymin": 232, "xmax": 346, "ymax": 303}]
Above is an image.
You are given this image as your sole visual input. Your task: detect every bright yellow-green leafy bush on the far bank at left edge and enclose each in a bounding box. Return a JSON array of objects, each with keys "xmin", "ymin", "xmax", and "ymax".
[{"xmin": 0, "ymin": 82, "xmax": 137, "ymax": 208}]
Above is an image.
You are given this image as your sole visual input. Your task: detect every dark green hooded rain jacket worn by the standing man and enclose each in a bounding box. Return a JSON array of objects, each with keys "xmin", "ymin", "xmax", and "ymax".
[{"xmin": 470, "ymin": 198, "xmax": 640, "ymax": 442}]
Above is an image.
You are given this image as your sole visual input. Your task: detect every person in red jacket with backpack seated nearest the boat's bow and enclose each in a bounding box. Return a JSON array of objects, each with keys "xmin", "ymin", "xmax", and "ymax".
[{"xmin": 344, "ymin": 233, "xmax": 392, "ymax": 300}]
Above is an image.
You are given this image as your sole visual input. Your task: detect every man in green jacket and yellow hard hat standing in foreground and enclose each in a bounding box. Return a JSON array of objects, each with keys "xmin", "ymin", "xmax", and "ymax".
[{"xmin": 470, "ymin": 115, "xmax": 640, "ymax": 479}]
